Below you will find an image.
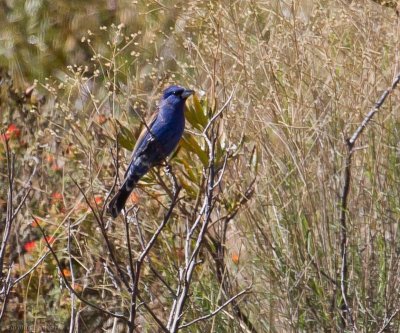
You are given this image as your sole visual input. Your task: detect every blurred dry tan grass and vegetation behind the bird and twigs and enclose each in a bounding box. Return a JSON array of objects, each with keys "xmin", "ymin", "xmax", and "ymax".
[{"xmin": 0, "ymin": 0, "xmax": 400, "ymax": 332}]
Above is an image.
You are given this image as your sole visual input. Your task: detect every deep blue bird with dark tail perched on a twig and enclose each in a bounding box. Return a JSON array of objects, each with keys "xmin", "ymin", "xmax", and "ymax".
[{"xmin": 108, "ymin": 86, "xmax": 194, "ymax": 218}]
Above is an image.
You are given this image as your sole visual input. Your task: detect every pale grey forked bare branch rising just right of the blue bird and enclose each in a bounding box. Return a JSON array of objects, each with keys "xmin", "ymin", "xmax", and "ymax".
[{"xmin": 167, "ymin": 87, "xmax": 255, "ymax": 333}]
